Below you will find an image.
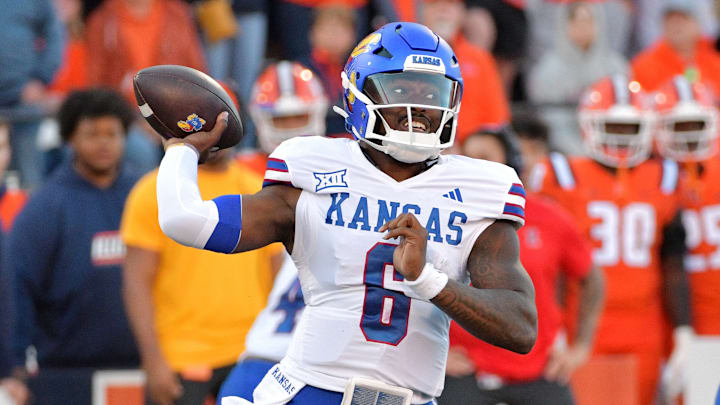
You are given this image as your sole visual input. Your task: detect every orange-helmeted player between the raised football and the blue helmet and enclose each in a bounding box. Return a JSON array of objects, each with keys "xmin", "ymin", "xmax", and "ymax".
[{"xmin": 238, "ymin": 61, "xmax": 328, "ymax": 176}]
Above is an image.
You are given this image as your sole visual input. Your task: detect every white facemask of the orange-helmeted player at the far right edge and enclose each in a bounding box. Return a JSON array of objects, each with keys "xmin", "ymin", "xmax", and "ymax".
[{"xmin": 657, "ymin": 103, "xmax": 718, "ymax": 162}]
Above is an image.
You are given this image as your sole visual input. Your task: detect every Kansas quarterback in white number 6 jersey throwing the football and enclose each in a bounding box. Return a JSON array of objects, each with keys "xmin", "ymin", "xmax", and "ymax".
[{"xmin": 153, "ymin": 23, "xmax": 536, "ymax": 405}]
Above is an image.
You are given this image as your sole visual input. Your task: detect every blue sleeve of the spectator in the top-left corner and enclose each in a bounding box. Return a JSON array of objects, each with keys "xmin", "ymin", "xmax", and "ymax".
[{"xmin": 33, "ymin": 0, "xmax": 65, "ymax": 84}]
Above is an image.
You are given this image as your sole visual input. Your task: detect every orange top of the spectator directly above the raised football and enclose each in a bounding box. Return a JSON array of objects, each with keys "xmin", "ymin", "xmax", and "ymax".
[{"xmin": 85, "ymin": 0, "xmax": 206, "ymax": 101}]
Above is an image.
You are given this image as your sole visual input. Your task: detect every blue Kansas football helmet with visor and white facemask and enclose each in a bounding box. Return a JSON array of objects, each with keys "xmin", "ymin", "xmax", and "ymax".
[{"xmin": 334, "ymin": 22, "xmax": 463, "ymax": 163}]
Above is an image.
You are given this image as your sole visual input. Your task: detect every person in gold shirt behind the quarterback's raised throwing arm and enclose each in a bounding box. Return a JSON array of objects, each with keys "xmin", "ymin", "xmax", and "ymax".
[{"xmin": 121, "ymin": 151, "xmax": 282, "ymax": 405}]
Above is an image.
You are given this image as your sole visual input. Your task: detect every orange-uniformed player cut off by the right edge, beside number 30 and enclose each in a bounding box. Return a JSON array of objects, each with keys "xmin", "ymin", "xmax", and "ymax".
[{"xmin": 652, "ymin": 76, "xmax": 720, "ymax": 397}]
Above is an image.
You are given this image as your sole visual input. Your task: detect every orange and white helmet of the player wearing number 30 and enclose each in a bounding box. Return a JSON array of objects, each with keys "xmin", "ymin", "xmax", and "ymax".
[{"xmin": 578, "ymin": 75, "xmax": 652, "ymax": 167}]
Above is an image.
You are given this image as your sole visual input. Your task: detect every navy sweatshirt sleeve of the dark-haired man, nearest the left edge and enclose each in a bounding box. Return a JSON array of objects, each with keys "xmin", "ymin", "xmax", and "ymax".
[{"xmin": 6, "ymin": 193, "xmax": 60, "ymax": 366}]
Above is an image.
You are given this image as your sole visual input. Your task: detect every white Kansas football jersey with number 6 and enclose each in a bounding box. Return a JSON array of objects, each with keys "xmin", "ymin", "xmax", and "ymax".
[{"xmin": 264, "ymin": 137, "xmax": 525, "ymax": 403}]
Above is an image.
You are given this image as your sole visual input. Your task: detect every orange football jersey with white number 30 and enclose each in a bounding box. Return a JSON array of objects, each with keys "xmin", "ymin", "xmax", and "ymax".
[{"xmin": 531, "ymin": 153, "xmax": 679, "ymax": 352}]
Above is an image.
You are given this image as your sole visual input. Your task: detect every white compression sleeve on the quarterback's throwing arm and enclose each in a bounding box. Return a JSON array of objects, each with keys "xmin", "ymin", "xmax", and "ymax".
[{"xmin": 157, "ymin": 145, "xmax": 219, "ymax": 249}]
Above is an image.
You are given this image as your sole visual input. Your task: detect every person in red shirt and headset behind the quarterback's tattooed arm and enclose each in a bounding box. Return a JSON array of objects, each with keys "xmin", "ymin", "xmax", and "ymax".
[{"xmin": 440, "ymin": 123, "xmax": 603, "ymax": 405}]
